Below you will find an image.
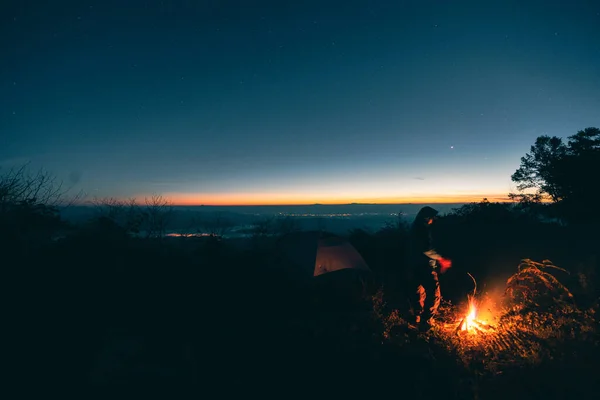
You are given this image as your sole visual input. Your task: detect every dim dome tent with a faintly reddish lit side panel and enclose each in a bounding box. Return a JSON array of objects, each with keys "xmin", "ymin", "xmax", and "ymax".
[{"xmin": 277, "ymin": 232, "xmax": 370, "ymax": 278}]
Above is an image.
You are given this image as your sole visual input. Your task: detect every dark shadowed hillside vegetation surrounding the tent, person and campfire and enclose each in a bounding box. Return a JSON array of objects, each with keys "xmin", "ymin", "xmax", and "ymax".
[{"xmin": 0, "ymin": 128, "xmax": 600, "ymax": 399}]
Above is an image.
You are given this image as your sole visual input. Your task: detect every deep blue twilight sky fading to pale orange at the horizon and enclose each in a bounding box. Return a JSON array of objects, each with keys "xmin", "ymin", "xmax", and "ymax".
[{"xmin": 0, "ymin": 0, "xmax": 600, "ymax": 204}]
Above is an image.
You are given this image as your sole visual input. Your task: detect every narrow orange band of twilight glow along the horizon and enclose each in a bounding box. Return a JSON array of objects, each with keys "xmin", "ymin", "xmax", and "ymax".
[{"xmin": 131, "ymin": 193, "xmax": 510, "ymax": 206}]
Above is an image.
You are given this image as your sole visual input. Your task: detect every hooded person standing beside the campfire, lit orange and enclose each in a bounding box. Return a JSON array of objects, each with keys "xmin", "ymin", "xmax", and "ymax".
[{"xmin": 410, "ymin": 206, "xmax": 452, "ymax": 331}]
